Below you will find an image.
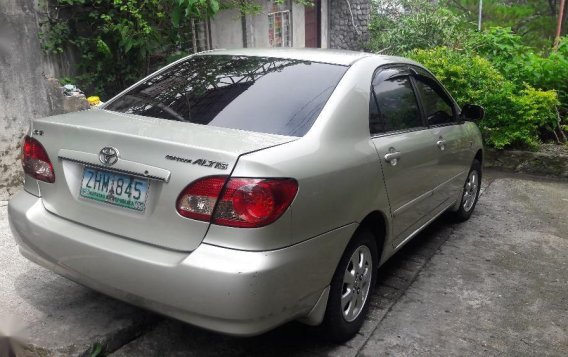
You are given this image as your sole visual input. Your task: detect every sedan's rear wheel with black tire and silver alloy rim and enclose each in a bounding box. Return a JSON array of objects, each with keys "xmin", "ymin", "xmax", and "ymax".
[{"xmin": 322, "ymin": 231, "xmax": 378, "ymax": 343}]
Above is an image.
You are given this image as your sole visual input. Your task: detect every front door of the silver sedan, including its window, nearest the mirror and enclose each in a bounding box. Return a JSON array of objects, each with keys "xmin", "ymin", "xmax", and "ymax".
[{"xmin": 413, "ymin": 67, "xmax": 473, "ymax": 204}]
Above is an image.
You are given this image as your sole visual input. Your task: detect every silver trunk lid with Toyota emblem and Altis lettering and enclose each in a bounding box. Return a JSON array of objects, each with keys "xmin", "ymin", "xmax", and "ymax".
[{"xmin": 33, "ymin": 109, "xmax": 297, "ymax": 251}]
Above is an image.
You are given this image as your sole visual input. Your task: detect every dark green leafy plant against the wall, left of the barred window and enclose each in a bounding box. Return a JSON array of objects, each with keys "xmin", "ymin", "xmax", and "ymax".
[{"xmin": 41, "ymin": 0, "xmax": 182, "ymax": 97}]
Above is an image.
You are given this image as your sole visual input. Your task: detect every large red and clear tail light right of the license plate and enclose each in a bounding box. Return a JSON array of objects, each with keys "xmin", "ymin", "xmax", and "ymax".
[{"xmin": 176, "ymin": 176, "xmax": 298, "ymax": 228}]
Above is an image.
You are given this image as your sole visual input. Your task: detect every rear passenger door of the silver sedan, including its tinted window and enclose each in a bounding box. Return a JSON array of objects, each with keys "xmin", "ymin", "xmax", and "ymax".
[{"xmin": 369, "ymin": 66, "xmax": 438, "ymax": 245}]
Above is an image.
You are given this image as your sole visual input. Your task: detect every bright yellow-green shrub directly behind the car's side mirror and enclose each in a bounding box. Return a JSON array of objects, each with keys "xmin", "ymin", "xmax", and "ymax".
[{"xmin": 409, "ymin": 47, "xmax": 558, "ymax": 149}]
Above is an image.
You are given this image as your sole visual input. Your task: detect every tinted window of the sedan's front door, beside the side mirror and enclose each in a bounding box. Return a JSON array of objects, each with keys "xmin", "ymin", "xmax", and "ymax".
[{"xmin": 410, "ymin": 77, "xmax": 454, "ymax": 125}]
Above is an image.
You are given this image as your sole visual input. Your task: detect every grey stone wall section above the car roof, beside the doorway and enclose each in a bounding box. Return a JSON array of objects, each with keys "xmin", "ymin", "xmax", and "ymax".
[{"xmin": 329, "ymin": 0, "xmax": 371, "ymax": 50}]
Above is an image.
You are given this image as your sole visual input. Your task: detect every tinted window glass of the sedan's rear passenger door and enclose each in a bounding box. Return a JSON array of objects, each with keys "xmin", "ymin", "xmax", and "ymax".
[{"xmin": 370, "ymin": 76, "xmax": 423, "ymax": 133}]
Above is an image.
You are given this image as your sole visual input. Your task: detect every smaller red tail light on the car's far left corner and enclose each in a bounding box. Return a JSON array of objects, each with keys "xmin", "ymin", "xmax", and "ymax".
[{"xmin": 22, "ymin": 135, "xmax": 55, "ymax": 183}]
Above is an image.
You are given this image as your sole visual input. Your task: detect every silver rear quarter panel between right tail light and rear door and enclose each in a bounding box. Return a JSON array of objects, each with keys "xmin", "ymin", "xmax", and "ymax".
[{"xmin": 204, "ymin": 58, "xmax": 389, "ymax": 250}]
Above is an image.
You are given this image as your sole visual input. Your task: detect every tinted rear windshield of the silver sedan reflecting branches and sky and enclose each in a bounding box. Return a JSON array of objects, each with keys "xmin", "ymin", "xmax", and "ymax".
[{"xmin": 105, "ymin": 55, "xmax": 347, "ymax": 136}]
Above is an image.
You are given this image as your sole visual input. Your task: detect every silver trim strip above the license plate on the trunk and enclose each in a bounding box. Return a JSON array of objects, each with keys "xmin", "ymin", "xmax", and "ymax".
[{"xmin": 57, "ymin": 149, "xmax": 171, "ymax": 183}]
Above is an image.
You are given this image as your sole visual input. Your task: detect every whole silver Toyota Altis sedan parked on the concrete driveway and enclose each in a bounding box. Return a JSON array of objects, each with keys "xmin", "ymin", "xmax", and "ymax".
[{"xmin": 8, "ymin": 49, "xmax": 483, "ymax": 341}]
